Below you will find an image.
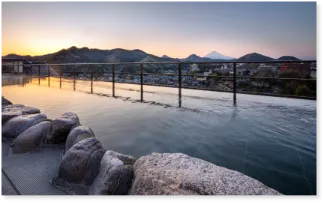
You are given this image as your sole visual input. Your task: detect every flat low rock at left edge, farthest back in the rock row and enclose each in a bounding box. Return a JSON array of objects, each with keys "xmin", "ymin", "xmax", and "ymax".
[{"xmin": 1, "ymin": 104, "xmax": 40, "ymax": 124}]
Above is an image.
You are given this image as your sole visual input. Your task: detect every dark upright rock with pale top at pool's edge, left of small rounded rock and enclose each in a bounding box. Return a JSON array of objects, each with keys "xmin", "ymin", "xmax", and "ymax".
[{"xmin": 46, "ymin": 112, "xmax": 80, "ymax": 144}]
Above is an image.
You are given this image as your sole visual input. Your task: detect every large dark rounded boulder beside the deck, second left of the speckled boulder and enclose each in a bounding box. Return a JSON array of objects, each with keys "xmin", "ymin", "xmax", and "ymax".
[{"xmin": 53, "ymin": 137, "xmax": 104, "ymax": 186}]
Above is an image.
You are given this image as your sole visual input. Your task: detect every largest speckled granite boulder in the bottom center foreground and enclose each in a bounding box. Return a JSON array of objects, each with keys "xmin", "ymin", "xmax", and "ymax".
[{"xmin": 129, "ymin": 153, "xmax": 281, "ymax": 196}]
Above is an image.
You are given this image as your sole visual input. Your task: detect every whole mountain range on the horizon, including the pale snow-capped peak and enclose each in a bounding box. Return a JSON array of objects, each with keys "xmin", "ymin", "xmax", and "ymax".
[{"xmin": 4, "ymin": 46, "xmax": 300, "ymax": 63}]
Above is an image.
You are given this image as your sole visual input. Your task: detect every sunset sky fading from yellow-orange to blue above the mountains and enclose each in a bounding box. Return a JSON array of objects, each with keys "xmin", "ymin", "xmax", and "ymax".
[{"xmin": 0, "ymin": 0, "xmax": 317, "ymax": 59}]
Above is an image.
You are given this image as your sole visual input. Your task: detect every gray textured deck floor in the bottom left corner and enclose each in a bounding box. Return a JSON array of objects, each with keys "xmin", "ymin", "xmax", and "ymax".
[{"xmin": 0, "ymin": 142, "xmax": 68, "ymax": 196}]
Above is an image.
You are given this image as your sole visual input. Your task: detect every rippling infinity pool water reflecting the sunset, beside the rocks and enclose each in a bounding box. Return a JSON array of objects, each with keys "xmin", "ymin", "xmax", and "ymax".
[{"xmin": 0, "ymin": 78, "xmax": 317, "ymax": 195}]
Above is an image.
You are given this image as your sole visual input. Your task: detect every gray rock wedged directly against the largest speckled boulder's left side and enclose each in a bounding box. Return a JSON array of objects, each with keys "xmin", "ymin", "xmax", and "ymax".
[{"xmin": 89, "ymin": 151, "xmax": 133, "ymax": 196}]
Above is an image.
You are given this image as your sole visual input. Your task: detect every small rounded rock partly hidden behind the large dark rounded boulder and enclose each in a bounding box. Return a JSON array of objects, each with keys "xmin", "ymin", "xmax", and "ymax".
[{"xmin": 65, "ymin": 126, "xmax": 95, "ymax": 153}]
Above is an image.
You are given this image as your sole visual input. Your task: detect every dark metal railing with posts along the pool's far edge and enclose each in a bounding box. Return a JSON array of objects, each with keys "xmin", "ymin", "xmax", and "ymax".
[{"xmin": 0, "ymin": 60, "xmax": 317, "ymax": 107}]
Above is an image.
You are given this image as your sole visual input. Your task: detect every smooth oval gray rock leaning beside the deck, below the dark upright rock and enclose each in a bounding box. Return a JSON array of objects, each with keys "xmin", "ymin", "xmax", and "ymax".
[{"xmin": 11, "ymin": 121, "xmax": 51, "ymax": 154}]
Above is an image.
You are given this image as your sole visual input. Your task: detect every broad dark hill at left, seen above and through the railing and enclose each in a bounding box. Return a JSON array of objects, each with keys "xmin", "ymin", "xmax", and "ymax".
[{"xmin": 1, "ymin": 46, "xmax": 179, "ymax": 72}]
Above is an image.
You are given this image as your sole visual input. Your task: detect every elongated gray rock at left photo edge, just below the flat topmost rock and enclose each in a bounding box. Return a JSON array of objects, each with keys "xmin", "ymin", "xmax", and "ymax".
[{"xmin": 1, "ymin": 114, "xmax": 46, "ymax": 138}]
